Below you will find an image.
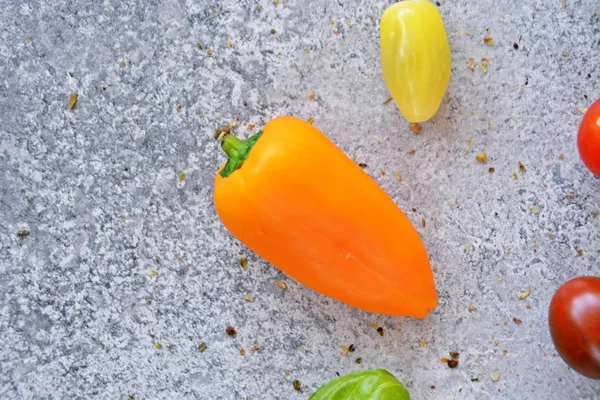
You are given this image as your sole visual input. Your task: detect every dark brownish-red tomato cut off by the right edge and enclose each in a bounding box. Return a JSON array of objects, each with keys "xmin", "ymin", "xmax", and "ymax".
[{"xmin": 548, "ymin": 276, "xmax": 600, "ymax": 379}]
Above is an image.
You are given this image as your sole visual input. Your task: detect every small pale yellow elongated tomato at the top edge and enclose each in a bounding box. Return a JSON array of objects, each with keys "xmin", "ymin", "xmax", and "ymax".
[{"xmin": 379, "ymin": 0, "xmax": 452, "ymax": 122}]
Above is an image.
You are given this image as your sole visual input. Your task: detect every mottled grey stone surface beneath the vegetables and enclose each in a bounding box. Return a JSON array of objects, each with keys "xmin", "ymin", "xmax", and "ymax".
[{"xmin": 0, "ymin": 0, "xmax": 600, "ymax": 399}]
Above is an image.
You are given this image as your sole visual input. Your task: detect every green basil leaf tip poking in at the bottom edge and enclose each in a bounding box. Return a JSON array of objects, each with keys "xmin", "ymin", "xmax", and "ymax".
[{"xmin": 309, "ymin": 369, "xmax": 410, "ymax": 400}]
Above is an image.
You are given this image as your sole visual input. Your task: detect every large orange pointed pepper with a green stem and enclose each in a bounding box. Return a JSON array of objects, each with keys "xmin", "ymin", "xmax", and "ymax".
[{"xmin": 214, "ymin": 117, "xmax": 437, "ymax": 318}]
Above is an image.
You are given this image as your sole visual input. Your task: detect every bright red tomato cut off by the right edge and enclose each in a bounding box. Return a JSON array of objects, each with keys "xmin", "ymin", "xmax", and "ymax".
[{"xmin": 577, "ymin": 99, "xmax": 600, "ymax": 177}]
